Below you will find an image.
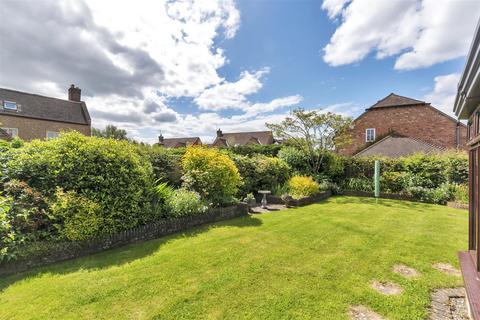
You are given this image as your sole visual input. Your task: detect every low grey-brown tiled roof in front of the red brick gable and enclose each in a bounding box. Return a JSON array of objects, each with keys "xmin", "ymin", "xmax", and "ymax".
[{"xmin": 355, "ymin": 135, "xmax": 444, "ymax": 158}]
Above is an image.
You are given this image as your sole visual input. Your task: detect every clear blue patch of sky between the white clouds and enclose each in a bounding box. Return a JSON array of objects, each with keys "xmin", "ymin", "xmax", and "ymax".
[{"xmin": 220, "ymin": 1, "xmax": 468, "ymax": 115}]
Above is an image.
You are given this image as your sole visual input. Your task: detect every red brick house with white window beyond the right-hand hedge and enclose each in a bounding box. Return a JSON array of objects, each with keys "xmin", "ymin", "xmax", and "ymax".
[{"xmin": 340, "ymin": 93, "xmax": 467, "ymax": 157}]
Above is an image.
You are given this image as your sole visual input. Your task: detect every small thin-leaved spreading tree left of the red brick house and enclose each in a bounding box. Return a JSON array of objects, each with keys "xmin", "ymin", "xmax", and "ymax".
[{"xmin": 266, "ymin": 109, "xmax": 352, "ymax": 174}]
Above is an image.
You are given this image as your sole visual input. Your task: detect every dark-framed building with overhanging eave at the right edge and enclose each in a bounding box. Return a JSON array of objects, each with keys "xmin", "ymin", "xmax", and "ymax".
[{"xmin": 454, "ymin": 18, "xmax": 480, "ymax": 320}]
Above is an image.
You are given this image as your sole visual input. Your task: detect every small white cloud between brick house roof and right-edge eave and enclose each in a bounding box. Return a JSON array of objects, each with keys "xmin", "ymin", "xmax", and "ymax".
[{"xmin": 424, "ymin": 73, "xmax": 460, "ymax": 118}]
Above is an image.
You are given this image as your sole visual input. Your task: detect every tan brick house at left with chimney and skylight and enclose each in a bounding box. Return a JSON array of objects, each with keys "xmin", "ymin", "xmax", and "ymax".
[{"xmin": 0, "ymin": 84, "xmax": 91, "ymax": 140}]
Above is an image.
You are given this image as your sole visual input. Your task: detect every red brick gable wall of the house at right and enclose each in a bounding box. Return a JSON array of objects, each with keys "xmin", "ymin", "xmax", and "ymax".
[{"xmin": 340, "ymin": 106, "xmax": 467, "ymax": 154}]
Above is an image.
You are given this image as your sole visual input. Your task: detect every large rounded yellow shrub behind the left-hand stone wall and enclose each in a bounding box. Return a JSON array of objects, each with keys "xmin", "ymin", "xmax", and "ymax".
[{"xmin": 182, "ymin": 147, "xmax": 241, "ymax": 206}]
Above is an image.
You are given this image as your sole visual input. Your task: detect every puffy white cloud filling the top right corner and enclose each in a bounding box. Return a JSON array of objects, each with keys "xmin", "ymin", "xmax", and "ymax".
[{"xmin": 322, "ymin": 0, "xmax": 480, "ymax": 70}]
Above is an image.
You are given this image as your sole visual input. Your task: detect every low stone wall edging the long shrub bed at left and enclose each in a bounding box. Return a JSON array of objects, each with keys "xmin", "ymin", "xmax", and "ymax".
[{"xmin": 0, "ymin": 203, "xmax": 248, "ymax": 276}]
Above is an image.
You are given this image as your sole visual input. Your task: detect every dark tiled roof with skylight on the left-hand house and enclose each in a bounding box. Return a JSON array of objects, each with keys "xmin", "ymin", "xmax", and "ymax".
[{"xmin": 0, "ymin": 88, "xmax": 90, "ymax": 124}]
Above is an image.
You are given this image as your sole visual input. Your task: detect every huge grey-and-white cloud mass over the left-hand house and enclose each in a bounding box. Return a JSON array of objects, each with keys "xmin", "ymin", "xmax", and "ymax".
[{"xmin": 0, "ymin": 0, "xmax": 301, "ymax": 142}]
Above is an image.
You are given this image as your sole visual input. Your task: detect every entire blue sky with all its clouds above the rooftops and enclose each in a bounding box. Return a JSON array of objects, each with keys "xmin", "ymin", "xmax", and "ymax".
[{"xmin": 0, "ymin": 0, "xmax": 480, "ymax": 143}]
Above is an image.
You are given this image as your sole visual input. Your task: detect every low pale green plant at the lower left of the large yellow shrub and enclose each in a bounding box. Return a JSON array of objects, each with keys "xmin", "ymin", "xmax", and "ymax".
[{"xmin": 166, "ymin": 188, "xmax": 207, "ymax": 217}]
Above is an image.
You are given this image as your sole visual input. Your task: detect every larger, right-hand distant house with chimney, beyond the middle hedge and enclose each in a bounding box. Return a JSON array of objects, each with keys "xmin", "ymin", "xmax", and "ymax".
[{"xmin": 212, "ymin": 129, "xmax": 275, "ymax": 147}]
